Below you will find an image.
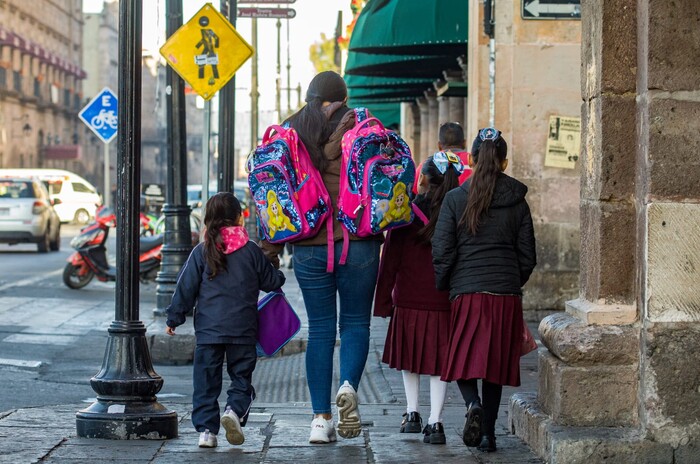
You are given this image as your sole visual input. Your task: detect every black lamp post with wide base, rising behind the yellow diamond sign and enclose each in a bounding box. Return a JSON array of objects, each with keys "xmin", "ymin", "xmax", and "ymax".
[{"xmin": 153, "ymin": 0, "xmax": 192, "ymax": 316}]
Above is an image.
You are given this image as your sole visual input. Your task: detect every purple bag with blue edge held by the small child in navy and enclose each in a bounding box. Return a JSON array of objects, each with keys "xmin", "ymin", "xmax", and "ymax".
[{"xmin": 257, "ymin": 289, "xmax": 301, "ymax": 356}]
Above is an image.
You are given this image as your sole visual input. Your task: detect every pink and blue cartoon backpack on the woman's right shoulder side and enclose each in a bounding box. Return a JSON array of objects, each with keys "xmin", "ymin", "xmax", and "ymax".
[{"xmin": 337, "ymin": 108, "xmax": 416, "ymax": 264}]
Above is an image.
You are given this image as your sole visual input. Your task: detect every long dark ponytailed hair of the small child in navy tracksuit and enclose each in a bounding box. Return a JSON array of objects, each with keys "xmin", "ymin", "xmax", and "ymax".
[{"xmin": 204, "ymin": 192, "xmax": 242, "ymax": 280}]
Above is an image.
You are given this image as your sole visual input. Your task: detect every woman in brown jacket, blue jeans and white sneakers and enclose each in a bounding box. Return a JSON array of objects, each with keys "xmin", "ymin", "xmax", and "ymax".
[{"xmin": 262, "ymin": 71, "xmax": 383, "ymax": 443}]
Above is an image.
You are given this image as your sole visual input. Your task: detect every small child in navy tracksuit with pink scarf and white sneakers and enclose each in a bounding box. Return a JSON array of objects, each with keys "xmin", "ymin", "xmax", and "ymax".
[{"xmin": 166, "ymin": 192, "xmax": 285, "ymax": 448}]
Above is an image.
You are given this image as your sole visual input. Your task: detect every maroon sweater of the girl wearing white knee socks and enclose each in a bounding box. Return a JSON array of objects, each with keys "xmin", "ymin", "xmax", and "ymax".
[{"xmin": 374, "ymin": 218, "xmax": 450, "ymax": 317}]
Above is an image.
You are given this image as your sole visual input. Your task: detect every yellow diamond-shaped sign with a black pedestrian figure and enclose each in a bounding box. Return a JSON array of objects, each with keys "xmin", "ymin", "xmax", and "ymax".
[{"xmin": 160, "ymin": 3, "xmax": 254, "ymax": 100}]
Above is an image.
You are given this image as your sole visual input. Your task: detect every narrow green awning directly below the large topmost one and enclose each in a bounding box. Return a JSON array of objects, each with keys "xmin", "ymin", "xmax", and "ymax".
[{"xmin": 345, "ymin": 52, "xmax": 458, "ymax": 79}]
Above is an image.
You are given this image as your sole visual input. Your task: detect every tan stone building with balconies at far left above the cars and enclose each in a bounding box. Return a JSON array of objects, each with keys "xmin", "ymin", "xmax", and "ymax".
[{"xmin": 0, "ymin": 0, "xmax": 87, "ymax": 180}]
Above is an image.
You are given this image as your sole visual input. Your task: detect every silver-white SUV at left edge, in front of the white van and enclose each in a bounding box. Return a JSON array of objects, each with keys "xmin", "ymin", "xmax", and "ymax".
[{"xmin": 0, "ymin": 174, "xmax": 61, "ymax": 253}]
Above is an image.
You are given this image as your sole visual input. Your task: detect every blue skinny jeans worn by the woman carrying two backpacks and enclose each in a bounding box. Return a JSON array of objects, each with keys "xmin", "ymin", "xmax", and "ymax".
[{"xmin": 293, "ymin": 240, "xmax": 381, "ymax": 414}]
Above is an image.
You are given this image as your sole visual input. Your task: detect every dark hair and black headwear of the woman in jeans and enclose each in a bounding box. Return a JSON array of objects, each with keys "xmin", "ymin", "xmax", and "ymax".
[{"xmin": 285, "ymin": 71, "xmax": 348, "ymax": 172}]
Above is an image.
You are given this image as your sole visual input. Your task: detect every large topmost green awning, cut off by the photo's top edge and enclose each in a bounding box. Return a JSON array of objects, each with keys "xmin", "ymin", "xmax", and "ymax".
[{"xmin": 349, "ymin": 0, "xmax": 469, "ymax": 56}]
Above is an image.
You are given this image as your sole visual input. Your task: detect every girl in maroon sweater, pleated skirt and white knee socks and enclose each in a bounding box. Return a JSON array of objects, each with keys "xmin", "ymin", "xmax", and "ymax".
[{"xmin": 374, "ymin": 152, "xmax": 463, "ymax": 444}]
